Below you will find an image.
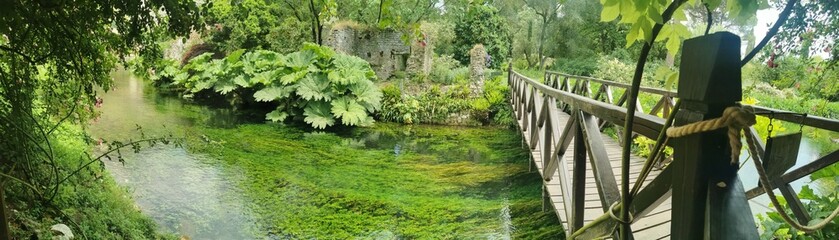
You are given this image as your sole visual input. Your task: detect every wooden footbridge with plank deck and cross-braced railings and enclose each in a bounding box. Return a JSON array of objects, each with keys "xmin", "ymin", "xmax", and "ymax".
[{"xmin": 508, "ymin": 32, "xmax": 839, "ymax": 239}]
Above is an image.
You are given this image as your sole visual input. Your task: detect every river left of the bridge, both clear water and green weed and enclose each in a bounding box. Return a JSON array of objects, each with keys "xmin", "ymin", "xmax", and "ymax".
[{"xmin": 90, "ymin": 71, "xmax": 562, "ymax": 239}]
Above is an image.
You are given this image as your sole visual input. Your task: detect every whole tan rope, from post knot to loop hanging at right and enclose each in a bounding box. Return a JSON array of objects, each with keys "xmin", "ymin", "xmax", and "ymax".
[{"xmin": 667, "ymin": 107, "xmax": 839, "ymax": 232}]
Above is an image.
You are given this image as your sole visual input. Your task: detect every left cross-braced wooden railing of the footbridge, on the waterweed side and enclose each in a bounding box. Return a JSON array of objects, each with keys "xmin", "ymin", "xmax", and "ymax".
[{"xmin": 509, "ymin": 70, "xmax": 669, "ymax": 238}]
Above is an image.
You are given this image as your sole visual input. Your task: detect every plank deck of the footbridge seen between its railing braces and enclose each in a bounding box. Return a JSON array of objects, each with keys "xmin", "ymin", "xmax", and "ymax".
[{"xmin": 518, "ymin": 101, "xmax": 671, "ymax": 240}]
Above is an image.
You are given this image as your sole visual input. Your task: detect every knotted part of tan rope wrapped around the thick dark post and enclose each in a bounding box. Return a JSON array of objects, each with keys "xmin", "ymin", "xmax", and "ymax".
[{"xmin": 667, "ymin": 107, "xmax": 756, "ymax": 165}]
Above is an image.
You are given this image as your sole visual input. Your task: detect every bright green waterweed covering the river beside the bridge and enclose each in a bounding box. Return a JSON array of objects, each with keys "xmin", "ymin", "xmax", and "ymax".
[{"xmin": 189, "ymin": 123, "xmax": 562, "ymax": 239}]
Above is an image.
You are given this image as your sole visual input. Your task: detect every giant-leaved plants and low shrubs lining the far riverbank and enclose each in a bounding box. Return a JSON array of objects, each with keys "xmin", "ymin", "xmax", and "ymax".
[{"xmin": 135, "ymin": 43, "xmax": 515, "ymax": 129}]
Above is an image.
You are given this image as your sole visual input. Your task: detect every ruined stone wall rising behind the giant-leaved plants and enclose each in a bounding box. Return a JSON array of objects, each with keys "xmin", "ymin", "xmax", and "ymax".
[{"xmin": 324, "ymin": 24, "xmax": 433, "ymax": 80}]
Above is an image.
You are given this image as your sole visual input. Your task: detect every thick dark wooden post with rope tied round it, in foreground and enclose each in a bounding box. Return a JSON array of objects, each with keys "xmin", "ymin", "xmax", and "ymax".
[{"xmin": 671, "ymin": 32, "xmax": 758, "ymax": 239}]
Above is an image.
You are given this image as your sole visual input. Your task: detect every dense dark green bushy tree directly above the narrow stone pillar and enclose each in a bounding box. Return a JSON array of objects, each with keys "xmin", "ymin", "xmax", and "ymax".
[{"xmin": 453, "ymin": 4, "xmax": 509, "ymax": 68}]
